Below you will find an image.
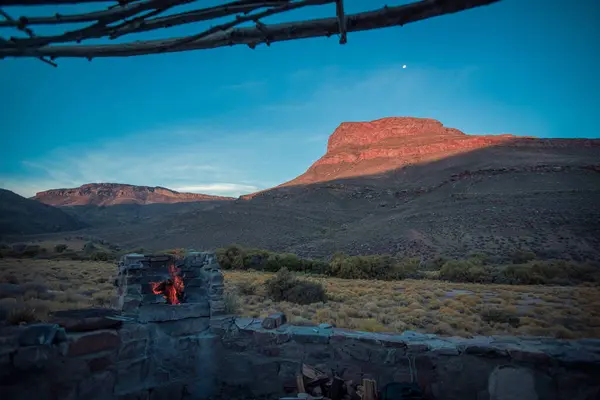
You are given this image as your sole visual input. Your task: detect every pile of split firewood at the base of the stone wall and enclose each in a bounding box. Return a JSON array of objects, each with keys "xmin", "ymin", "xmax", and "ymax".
[{"xmin": 279, "ymin": 364, "xmax": 378, "ymax": 400}]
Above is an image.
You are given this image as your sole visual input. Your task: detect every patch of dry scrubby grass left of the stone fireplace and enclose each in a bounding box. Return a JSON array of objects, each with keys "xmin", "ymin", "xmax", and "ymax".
[{"xmin": 0, "ymin": 259, "xmax": 116, "ymax": 323}]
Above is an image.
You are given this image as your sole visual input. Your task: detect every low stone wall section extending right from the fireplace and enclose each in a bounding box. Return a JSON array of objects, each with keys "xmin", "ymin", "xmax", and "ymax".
[{"xmin": 215, "ymin": 318, "xmax": 600, "ymax": 400}]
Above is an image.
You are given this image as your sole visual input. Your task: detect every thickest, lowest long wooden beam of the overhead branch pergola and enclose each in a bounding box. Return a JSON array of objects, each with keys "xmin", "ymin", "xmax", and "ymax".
[{"xmin": 0, "ymin": 0, "xmax": 500, "ymax": 58}]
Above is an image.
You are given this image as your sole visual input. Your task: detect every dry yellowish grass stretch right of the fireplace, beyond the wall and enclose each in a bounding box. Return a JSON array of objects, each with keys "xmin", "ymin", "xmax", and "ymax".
[{"xmin": 225, "ymin": 271, "xmax": 600, "ymax": 338}]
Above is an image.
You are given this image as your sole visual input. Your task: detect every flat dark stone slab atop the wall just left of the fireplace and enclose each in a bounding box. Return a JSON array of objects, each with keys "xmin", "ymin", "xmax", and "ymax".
[{"xmin": 52, "ymin": 308, "xmax": 123, "ymax": 332}]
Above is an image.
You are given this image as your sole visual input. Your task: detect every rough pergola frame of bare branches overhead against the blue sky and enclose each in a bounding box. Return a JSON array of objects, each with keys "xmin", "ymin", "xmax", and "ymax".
[{"xmin": 0, "ymin": 0, "xmax": 499, "ymax": 66}]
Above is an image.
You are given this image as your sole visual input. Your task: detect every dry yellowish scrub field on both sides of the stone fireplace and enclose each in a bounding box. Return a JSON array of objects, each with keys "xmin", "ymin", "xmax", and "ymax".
[{"xmin": 0, "ymin": 258, "xmax": 600, "ymax": 338}]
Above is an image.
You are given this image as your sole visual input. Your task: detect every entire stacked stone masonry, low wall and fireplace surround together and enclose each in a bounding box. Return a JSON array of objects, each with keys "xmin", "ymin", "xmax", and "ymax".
[{"xmin": 0, "ymin": 253, "xmax": 600, "ymax": 400}]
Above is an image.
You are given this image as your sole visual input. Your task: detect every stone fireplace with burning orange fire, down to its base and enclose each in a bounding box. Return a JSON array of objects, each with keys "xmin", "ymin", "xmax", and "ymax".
[{"xmin": 115, "ymin": 252, "xmax": 225, "ymax": 397}]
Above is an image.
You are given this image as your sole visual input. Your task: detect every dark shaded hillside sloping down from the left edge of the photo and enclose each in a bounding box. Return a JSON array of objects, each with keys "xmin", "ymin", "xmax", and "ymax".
[{"xmin": 0, "ymin": 189, "xmax": 87, "ymax": 235}]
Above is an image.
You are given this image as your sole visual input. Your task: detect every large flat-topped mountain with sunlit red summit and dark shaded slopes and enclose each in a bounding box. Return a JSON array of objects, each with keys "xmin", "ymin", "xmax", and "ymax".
[{"xmin": 39, "ymin": 118, "xmax": 600, "ymax": 259}]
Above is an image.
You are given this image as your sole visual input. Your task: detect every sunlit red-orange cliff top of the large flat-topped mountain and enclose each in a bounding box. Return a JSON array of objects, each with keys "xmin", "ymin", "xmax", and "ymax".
[{"xmin": 281, "ymin": 117, "xmax": 600, "ymax": 186}]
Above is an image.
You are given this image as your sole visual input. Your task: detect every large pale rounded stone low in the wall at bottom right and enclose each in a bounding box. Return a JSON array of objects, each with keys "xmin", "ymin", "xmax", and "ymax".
[{"xmin": 488, "ymin": 365, "xmax": 538, "ymax": 400}]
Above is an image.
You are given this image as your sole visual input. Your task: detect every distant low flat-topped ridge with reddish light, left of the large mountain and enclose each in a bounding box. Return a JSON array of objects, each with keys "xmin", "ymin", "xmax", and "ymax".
[{"xmin": 33, "ymin": 183, "xmax": 233, "ymax": 207}]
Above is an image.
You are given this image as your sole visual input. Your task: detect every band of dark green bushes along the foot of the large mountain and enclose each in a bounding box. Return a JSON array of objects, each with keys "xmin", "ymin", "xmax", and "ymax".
[{"xmin": 217, "ymin": 245, "xmax": 600, "ymax": 285}]
